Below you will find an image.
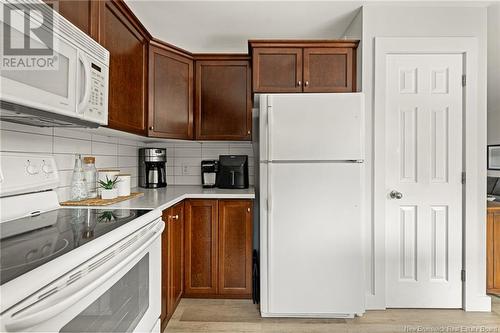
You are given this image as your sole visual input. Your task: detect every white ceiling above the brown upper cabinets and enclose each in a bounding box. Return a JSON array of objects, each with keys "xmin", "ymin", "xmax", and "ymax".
[{"xmin": 126, "ymin": 0, "xmax": 361, "ymax": 53}]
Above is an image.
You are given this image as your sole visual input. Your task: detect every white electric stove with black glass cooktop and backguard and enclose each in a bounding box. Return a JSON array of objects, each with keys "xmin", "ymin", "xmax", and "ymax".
[{"xmin": 0, "ymin": 153, "xmax": 164, "ymax": 332}]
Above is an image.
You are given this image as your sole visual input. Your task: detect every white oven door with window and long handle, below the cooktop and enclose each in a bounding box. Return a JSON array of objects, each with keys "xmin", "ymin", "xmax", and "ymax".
[{"xmin": 2, "ymin": 219, "xmax": 164, "ymax": 333}]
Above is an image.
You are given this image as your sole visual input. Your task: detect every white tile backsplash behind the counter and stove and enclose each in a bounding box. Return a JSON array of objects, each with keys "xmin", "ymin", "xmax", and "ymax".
[{"xmin": 0, "ymin": 122, "xmax": 254, "ymax": 201}]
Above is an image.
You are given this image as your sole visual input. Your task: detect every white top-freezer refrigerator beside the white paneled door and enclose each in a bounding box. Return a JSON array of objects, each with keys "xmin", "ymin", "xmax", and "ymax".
[{"xmin": 259, "ymin": 93, "xmax": 365, "ymax": 318}]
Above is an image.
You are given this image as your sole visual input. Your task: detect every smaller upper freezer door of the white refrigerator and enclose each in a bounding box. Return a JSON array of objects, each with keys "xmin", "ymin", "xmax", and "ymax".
[{"xmin": 260, "ymin": 93, "xmax": 364, "ymax": 161}]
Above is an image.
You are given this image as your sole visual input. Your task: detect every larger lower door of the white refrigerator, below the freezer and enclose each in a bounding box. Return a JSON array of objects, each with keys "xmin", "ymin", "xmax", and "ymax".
[{"xmin": 261, "ymin": 163, "xmax": 365, "ymax": 317}]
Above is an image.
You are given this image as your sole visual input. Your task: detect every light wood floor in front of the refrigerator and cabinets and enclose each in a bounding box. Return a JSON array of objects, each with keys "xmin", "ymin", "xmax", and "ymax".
[{"xmin": 164, "ymin": 297, "xmax": 500, "ymax": 333}]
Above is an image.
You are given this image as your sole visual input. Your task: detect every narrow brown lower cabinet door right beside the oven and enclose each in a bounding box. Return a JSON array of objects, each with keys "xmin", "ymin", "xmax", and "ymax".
[{"xmin": 168, "ymin": 202, "xmax": 184, "ymax": 318}]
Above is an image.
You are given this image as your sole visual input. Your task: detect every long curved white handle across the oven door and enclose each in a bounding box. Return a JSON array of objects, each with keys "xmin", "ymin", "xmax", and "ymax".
[{"xmin": 4, "ymin": 222, "xmax": 164, "ymax": 331}]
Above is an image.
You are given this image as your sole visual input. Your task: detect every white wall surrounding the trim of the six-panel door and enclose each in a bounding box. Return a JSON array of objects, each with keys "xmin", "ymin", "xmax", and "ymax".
[{"xmin": 362, "ymin": 5, "xmax": 487, "ymax": 309}]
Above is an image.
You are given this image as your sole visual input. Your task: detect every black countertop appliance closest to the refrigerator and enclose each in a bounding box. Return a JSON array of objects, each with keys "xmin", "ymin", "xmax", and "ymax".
[{"xmin": 216, "ymin": 155, "xmax": 248, "ymax": 188}]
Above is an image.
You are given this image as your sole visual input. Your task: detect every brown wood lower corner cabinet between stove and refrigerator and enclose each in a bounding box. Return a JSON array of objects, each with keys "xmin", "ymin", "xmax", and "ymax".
[{"xmin": 160, "ymin": 199, "xmax": 253, "ymax": 331}]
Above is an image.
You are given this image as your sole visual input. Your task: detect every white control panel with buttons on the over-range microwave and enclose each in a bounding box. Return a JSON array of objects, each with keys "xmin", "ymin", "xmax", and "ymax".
[{"xmin": 86, "ymin": 63, "xmax": 108, "ymax": 125}]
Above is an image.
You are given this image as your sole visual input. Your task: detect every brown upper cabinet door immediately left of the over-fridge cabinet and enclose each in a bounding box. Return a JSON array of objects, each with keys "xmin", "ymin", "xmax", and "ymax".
[{"xmin": 195, "ymin": 60, "xmax": 252, "ymax": 140}]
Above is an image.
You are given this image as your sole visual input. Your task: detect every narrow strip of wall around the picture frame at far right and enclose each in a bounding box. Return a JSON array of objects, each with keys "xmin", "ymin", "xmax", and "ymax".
[{"xmin": 488, "ymin": 3, "xmax": 500, "ymax": 177}]
